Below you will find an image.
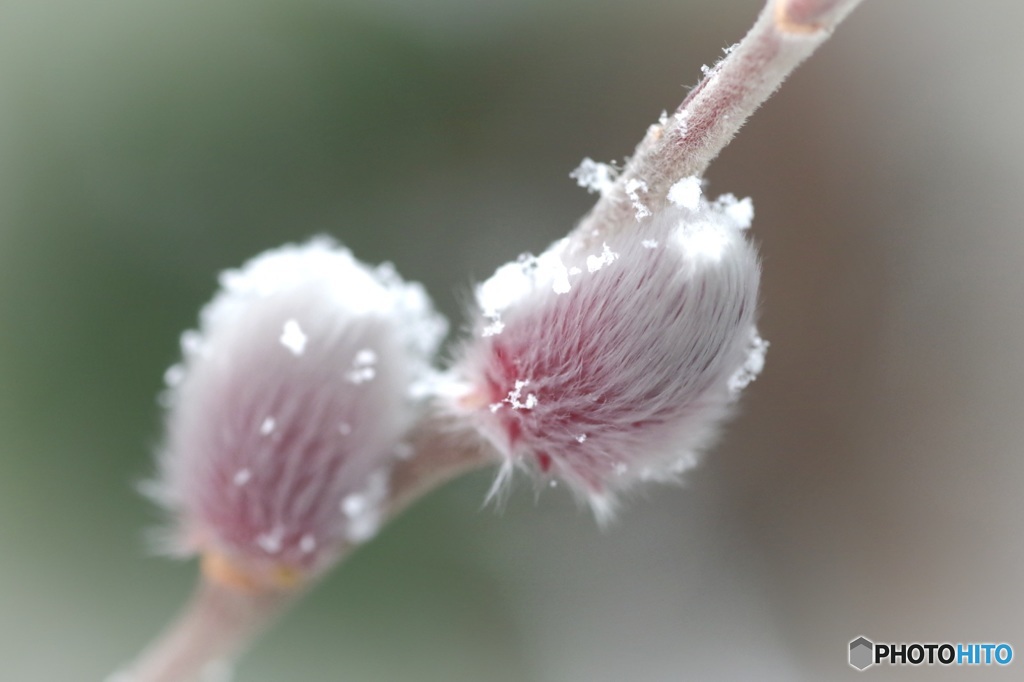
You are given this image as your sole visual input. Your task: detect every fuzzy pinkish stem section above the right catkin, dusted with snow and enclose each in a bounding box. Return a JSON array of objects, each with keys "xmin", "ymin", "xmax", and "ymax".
[{"xmin": 578, "ymin": 0, "xmax": 860, "ymax": 241}]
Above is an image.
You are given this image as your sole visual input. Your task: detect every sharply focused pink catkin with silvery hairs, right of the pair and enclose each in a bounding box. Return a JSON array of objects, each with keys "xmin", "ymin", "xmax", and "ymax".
[{"xmin": 454, "ymin": 186, "xmax": 765, "ymax": 516}]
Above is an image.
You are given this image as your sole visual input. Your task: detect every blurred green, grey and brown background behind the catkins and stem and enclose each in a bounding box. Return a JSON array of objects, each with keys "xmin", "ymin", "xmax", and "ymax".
[{"xmin": 0, "ymin": 0, "xmax": 1024, "ymax": 682}]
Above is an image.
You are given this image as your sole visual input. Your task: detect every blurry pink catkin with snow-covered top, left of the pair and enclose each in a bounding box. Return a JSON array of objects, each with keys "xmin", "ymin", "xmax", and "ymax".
[{"xmin": 151, "ymin": 240, "xmax": 445, "ymax": 574}]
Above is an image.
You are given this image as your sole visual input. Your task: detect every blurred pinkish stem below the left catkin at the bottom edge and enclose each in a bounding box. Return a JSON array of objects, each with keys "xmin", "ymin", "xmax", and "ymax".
[{"xmin": 117, "ymin": 576, "xmax": 302, "ymax": 682}]
